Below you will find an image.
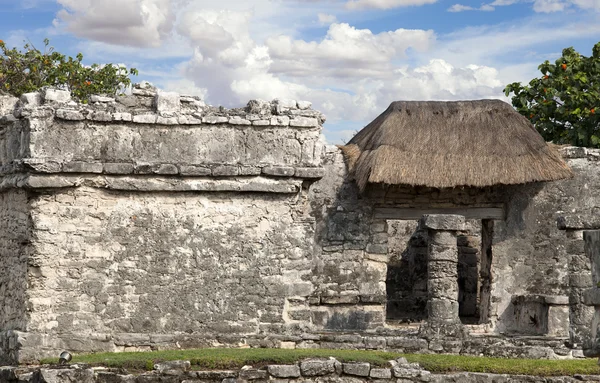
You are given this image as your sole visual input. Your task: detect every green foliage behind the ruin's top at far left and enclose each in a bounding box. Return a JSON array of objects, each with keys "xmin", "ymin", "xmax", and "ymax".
[{"xmin": 0, "ymin": 39, "xmax": 138, "ymax": 102}]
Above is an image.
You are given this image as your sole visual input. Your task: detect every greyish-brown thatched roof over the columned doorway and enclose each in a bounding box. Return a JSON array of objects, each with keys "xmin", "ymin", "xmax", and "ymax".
[{"xmin": 342, "ymin": 100, "xmax": 572, "ymax": 190}]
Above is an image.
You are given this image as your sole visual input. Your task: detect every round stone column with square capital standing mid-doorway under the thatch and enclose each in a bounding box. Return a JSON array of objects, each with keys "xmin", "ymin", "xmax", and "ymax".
[{"xmin": 421, "ymin": 214, "xmax": 465, "ymax": 324}]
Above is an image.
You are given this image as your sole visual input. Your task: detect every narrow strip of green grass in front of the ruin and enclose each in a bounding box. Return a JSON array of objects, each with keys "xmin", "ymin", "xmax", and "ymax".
[{"xmin": 43, "ymin": 348, "xmax": 600, "ymax": 376}]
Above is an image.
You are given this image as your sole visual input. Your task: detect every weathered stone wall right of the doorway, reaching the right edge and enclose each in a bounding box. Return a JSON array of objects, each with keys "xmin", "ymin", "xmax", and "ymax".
[{"xmin": 492, "ymin": 148, "xmax": 600, "ymax": 347}]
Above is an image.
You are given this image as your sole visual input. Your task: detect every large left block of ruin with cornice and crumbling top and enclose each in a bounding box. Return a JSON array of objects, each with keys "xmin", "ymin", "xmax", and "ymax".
[{"xmin": 0, "ymin": 87, "xmax": 324, "ymax": 361}]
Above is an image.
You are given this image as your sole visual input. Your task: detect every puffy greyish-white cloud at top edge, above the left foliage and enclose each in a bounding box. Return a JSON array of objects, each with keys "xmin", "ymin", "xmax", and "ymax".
[{"xmin": 54, "ymin": 0, "xmax": 178, "ymax": 47}]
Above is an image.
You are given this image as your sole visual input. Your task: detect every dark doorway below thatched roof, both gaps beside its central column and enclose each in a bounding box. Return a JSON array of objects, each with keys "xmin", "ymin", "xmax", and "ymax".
[{"xmin": 386, "ymin": 219, "xmax": 494, "ymax": 324}]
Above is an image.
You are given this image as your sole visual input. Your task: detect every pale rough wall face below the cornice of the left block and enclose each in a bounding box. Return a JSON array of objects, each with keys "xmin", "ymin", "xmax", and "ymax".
[{"xmin": 22, "ymin": 187, "xmax": 314, "ymax": 350}]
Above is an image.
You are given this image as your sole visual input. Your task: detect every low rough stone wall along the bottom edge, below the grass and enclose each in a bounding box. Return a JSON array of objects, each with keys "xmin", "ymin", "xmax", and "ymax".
[{"xmin": 0, "ymin": 358, "xmax": 600, "ymax": 383}]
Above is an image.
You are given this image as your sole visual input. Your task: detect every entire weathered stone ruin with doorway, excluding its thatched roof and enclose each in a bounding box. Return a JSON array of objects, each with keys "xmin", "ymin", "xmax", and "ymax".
[{"xmin": 0, "ymin": 85, "xmax": 600, "ymax": 365}]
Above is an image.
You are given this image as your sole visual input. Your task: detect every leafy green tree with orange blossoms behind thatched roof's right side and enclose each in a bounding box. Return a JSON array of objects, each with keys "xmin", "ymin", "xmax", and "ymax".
[{"xmin": 504, "ymin": 42, "xmax": 600, "ymax": 147}]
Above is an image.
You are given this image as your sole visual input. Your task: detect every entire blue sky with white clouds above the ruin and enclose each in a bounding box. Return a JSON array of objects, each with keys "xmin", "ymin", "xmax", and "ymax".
[{"xmin": 0, "ymin": 0, "xmax": 600, "ymax": 144}]
